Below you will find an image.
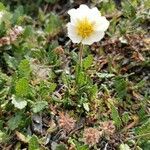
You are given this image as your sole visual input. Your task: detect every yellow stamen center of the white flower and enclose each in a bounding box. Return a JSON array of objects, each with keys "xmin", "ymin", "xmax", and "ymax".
[{"xmin": 76, "ymin": 17, "xmax": 94, "ymax": 39}]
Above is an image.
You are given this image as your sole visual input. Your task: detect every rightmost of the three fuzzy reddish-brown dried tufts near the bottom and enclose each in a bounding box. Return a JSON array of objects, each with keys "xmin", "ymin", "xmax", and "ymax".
[{"xmin": 100, "ymin": 121, "xmax": 116, "ymax": 136}]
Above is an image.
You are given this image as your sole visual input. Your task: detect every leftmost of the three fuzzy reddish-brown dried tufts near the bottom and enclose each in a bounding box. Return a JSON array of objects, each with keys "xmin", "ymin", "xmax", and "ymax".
[{"xmin": 58, "ymin": 113, "xmax": 76, "ymax": 133}]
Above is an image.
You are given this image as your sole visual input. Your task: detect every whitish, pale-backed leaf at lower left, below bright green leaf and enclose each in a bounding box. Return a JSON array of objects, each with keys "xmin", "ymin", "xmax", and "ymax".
[{"xmin": 11, "ymin": 95, "xmax": 27, "ymax": 109}]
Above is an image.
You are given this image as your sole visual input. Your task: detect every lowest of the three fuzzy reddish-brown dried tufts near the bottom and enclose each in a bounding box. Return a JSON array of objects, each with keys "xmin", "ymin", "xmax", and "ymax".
[{"xmin": 83, "ymin": 128, "xmax": 101, "ymax": 146}]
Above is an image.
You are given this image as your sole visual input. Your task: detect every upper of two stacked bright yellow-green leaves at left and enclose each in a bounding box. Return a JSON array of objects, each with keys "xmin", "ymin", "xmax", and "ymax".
[{"xmin": 18, "ymin": 59, "xmax": 31, "ymax": 78}]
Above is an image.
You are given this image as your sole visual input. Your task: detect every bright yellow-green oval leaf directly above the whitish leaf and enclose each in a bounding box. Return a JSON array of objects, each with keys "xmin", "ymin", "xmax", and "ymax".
[{"xmin": 15, "ymin": 78, "xmax": 30, "ymax": 97}]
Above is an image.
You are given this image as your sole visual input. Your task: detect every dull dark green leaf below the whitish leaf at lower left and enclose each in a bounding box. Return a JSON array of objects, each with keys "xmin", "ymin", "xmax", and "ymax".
[{"xmin": 8, "ymin": 114, "xmax": 22, "ymax": 130}]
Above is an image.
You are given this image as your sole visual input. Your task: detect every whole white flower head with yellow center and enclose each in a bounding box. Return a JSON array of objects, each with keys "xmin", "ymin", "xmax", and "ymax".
[{"xmin": 67, "ymin": 4, "xmax": 109, "ymax": 45}]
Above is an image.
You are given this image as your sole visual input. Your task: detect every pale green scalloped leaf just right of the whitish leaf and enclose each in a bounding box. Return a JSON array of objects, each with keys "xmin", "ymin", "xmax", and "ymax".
[{"xmin": 33, "ymin": 101, "xmax": 48, "ymax": 113}]
